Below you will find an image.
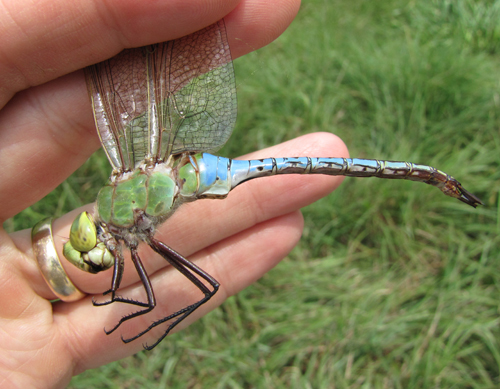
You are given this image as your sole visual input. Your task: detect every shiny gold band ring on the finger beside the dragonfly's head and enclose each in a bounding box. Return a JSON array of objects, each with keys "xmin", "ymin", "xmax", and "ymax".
[{"xmin": 31, "ymin": 217, "xmax": 85, "ymax": 302}]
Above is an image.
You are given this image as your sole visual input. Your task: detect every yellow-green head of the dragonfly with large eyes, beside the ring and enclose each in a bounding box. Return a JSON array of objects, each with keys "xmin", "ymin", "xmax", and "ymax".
[{"xmin": 63, "ymin": 212, "xmax": 114, "ymax": 273}]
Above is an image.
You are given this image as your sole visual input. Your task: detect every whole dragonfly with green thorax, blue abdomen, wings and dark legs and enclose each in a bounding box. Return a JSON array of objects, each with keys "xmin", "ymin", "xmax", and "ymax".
[{"xmin": 63, "ymin": 20, "xmax": 482, "ymax": 350}]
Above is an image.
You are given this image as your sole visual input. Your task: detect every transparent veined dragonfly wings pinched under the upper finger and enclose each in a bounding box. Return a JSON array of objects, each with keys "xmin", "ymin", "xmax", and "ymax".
[{"xmin": 86, "ymin": 20, "xmax": 236, "ymax": 171}]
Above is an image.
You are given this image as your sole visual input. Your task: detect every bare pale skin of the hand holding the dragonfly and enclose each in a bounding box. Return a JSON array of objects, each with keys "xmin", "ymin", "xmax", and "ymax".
[{"xmin": 0, "ymin": 0, "xmax": 347, "ymax": 387}]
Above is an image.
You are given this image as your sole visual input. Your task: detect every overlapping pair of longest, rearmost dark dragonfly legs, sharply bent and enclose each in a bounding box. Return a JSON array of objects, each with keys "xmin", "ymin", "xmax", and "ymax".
[{"xmin": 122, "ymin": 237, "xmax": 219, "ymax": 350}]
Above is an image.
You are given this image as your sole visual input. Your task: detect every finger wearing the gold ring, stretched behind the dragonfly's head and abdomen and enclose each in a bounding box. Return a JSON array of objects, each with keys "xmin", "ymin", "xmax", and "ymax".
[{"xmin": 12, "ymin": 133, "xmax": 347, "ymax": 298}]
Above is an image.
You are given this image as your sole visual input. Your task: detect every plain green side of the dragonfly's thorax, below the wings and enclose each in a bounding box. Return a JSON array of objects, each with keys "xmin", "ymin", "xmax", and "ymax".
[{"xmin": 97, "ymin": 169, "xmax": 177, "ymax": 228}]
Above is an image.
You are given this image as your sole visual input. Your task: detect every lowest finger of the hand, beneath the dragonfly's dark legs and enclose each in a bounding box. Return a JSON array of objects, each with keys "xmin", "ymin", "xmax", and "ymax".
[{"xmin": 54, "ymin": 212, "xmax": 302, "ymax": 374}]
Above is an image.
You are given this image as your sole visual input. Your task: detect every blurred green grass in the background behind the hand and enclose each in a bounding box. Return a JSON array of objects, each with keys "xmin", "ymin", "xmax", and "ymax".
[{"xmin": 6, "ymin": 0, "xmax": 500, "ymax": 388}]
